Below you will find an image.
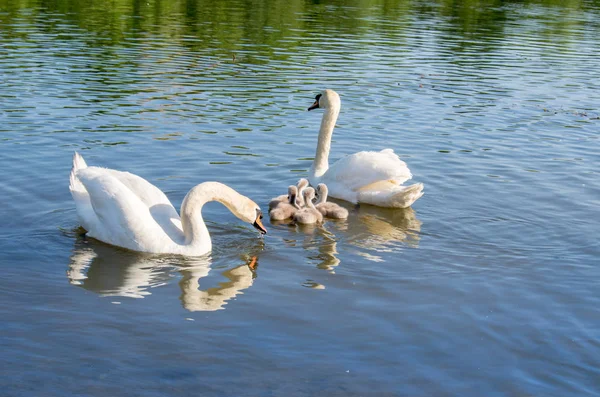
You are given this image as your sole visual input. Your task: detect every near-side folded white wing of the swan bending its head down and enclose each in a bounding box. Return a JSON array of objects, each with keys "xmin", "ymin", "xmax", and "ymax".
[{"xmin": 76, "ymin": 167, "xmax": 177, "ymax": 252}]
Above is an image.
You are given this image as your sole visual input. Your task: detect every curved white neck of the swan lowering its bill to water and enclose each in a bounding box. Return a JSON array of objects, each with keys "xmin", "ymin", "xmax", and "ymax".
[{"xmin": 181, "ymin": 182, "xmax": 243, "ymax": 251}]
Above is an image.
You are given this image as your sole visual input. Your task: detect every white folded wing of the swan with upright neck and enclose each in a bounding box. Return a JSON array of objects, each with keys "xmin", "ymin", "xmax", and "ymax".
[{"xmin": 326, "ymin": 149, "xmax": 412, "ymax": 191}]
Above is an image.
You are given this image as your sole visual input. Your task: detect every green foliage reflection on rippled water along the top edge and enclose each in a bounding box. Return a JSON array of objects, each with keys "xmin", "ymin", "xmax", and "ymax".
[{"xmin": 0, "ymin": 0, "xmax": 591, "ymax": 53}]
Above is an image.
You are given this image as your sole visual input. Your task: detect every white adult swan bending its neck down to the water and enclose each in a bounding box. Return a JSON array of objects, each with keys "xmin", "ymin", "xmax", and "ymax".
[{"xmin": 69, "ymin": 153, "xmax": 267, "ymax": 255}]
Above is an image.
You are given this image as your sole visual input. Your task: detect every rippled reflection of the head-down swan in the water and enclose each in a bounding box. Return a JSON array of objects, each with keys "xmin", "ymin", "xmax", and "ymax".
[{"xmin": 67, "ymin": 234, "xmax": 258, "ymax": 312}]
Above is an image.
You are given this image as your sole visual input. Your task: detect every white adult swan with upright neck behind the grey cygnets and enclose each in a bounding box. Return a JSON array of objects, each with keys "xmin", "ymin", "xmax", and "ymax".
[{"xmin": 308, "ymin": 90, "xmax": 423, "ymax": 208}]
